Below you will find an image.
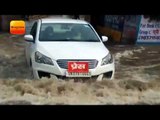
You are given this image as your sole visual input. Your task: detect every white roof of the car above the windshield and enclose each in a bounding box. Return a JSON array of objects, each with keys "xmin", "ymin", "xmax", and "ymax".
[{"xmin": 40, "ymin": 18, "xmax": 88, "ymax": 24}]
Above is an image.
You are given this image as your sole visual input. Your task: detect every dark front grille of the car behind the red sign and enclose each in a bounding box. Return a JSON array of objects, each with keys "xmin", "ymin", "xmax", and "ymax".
[{"xmin": 57, "ymin": 59, "xmax": 98, "ymax": 69}]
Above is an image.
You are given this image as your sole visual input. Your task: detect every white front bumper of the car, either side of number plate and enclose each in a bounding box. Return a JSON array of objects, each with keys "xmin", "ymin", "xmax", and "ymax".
[{"xmin": 32, "ymin": 61, "xmax": 115, "ymax": 79}]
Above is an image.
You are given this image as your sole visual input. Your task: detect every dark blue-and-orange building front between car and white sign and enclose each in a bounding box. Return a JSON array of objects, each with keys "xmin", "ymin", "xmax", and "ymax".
[{"xmin": 91, "ymin": 15, "xmax": 140, "ymax": 44}]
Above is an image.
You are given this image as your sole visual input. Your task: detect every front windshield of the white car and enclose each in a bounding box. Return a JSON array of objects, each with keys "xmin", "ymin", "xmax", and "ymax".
[{"xmin": 39, "ymin": 23, "xmax": 100, "ymax": 42}]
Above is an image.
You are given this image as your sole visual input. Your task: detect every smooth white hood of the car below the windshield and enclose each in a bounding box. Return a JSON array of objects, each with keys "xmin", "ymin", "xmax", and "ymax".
[{"xmin": 38, "ymin": 42, "xmax": 109, "ymax": 60}]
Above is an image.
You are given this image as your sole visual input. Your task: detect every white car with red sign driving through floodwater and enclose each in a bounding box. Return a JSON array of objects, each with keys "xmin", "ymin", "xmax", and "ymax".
[{"xmin": 24, "ymin": 18, "xmax": 115, "ymax": 80}]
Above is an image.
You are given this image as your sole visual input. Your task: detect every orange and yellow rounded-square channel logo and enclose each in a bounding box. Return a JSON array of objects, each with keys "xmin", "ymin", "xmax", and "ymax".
[{"xmin": 10, "ymin": 20, "xmax": 26, "ymax": 35}]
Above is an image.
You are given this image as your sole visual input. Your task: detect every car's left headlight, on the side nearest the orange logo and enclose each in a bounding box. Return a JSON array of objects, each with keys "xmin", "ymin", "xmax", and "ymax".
[{"xmin": 35, "ymin": 51, "xmax": 54, "ymax": 65}]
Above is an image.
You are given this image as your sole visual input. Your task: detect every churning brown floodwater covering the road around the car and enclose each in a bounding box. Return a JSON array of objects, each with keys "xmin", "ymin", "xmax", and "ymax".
[{"xmin": 0, "ymin": 34, "xmax": 160, "ymax": 104}]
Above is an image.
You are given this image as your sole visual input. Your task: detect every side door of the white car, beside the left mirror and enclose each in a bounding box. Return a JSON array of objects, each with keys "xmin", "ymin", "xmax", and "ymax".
[{"xmin": 26, "ymin": 22, "xmax": 37, "ymax": 64}]
